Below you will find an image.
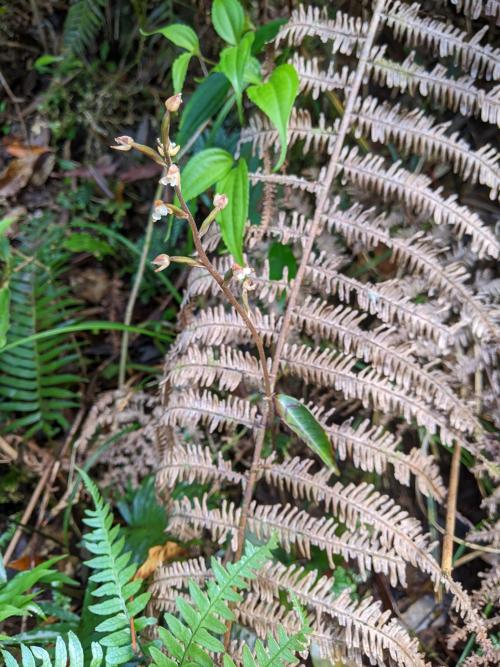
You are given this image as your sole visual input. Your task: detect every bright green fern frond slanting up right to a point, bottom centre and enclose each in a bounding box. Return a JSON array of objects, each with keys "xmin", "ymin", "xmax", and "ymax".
[{"xmin": 150, "ymin": 541, "xmax": 275, "ymax": 667}]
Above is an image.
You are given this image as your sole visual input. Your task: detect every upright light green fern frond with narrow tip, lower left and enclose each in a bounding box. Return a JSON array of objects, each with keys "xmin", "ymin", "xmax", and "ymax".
[{"xmin": 79, "ymin": 470, "xmax": 154, "ymax": 665}]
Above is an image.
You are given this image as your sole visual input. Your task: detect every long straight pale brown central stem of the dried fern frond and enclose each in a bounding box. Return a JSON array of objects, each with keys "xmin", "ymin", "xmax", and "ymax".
[{"xmin": 232, "ymin": 0, "xmax": 384, "ymax": 558}]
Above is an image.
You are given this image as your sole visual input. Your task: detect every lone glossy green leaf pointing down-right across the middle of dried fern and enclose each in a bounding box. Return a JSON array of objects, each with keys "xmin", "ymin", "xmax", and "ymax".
[{"xmin": 275, "ymin": 394, "xmax": 340, "ymax": 475}]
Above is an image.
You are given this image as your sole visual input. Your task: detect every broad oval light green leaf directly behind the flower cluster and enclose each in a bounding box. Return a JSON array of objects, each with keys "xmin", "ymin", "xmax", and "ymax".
[{"xmin": 181, "ymin": 148, "xmax": 233, "ymax": 201}]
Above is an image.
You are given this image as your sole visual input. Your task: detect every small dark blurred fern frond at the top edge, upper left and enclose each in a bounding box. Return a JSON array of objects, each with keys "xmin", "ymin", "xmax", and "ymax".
[{"xmin": 64, "ymin": 0, "xmax": 106, "ymax": 55}]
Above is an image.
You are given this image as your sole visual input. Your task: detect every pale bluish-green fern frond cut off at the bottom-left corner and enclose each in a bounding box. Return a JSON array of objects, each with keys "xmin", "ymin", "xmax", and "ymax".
[{"xmin": 2, "ymin": 631, "xmax": 103, "ymax": 667}]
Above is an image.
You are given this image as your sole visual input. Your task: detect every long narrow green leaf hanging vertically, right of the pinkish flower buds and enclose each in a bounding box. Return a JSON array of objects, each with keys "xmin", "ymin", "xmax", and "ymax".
[{"xmin": 216, "ymin": 158, "xmax": 249, "ymax": 264}]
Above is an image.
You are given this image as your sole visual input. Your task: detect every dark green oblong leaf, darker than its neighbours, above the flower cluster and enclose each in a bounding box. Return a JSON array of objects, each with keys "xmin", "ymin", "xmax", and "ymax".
[{"xmin": 175, "ymin": 72, "xmax": 230, "ymax": 146}]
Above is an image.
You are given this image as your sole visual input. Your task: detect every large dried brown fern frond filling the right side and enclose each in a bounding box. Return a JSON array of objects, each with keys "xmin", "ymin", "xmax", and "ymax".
[{"xmin": 157, "ymin": 0, "xmax": 500, "ymax": 666}]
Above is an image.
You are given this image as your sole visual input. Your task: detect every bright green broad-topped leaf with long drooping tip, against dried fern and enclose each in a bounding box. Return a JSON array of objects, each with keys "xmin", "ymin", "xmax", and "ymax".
[{"xmin": 247, "ymin": 65, "xmax": 299, "ymax": 171}]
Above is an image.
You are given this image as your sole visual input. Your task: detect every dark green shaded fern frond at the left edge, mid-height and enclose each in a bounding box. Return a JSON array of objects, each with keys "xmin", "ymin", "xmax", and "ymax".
[{"xmin": 0, "ymin": 260, "xmax": 81, "ymax": 438}]
